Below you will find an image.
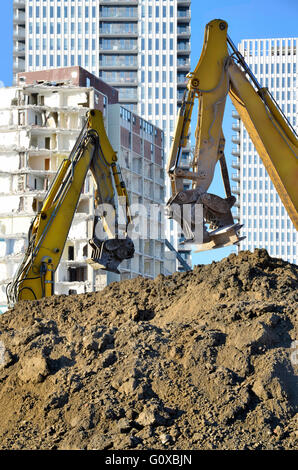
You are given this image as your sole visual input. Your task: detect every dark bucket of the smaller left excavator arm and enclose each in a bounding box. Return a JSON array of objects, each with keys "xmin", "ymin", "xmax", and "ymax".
[{"xmin": 87, "ymin": 237, "xmax": 135, "ymax": 274}]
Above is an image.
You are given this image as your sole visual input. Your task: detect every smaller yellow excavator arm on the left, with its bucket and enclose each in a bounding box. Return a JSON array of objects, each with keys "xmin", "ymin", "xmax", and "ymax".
[{"xmin": 7, "ymin": 110, "xmax": 134, "ymax": 305}]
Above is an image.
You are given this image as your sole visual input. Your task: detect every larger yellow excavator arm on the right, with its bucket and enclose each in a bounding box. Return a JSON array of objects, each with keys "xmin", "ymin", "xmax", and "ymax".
[{"xmin": 167, "ymin": 20, "xmax": 298, "ymax": 251}]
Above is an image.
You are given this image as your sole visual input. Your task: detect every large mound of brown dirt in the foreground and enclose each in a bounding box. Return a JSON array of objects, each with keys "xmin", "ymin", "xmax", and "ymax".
[{"xmin": 0, "ymin": 250, "xmax": 298, "ymax": 450}]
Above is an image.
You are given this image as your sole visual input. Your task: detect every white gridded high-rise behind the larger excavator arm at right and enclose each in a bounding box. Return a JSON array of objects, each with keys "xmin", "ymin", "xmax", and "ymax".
[{"xmin": 232, "ymin": 38, "xmax": 298, "ymax": 263}]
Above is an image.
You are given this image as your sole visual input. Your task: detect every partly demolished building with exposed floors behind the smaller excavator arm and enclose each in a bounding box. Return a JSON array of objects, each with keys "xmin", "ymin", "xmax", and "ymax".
[{"xmin": 0, "ymin": 67, "xmax": 170, "ymax": 308}]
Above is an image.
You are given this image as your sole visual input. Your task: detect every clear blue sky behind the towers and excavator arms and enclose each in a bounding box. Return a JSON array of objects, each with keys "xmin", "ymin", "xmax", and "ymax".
[{"xmin": 0, "ymin": 0, "xmax": 298, "ymax": 264}]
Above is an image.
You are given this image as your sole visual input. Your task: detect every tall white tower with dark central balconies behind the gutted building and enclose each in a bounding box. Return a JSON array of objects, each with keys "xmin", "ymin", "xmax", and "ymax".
[{"xmin": 13, "ymin": 0, "xmax": 191, "ymax": 267}]
